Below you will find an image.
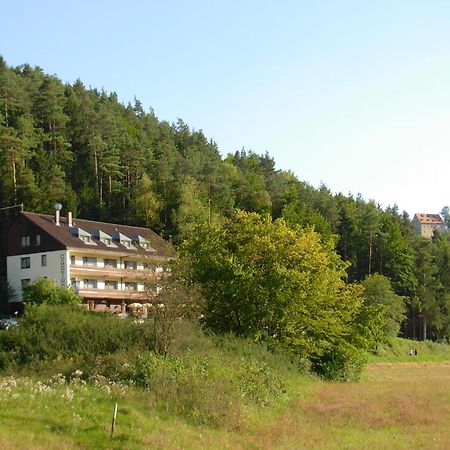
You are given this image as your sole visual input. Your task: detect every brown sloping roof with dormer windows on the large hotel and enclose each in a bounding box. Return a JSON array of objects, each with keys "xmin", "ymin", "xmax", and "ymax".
[{"xmin": 16, "ymin": 212, "xmax": 175, "ymax": 257}]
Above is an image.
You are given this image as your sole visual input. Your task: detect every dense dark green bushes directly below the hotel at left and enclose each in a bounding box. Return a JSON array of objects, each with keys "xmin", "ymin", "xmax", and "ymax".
[{"xmin": 0, "ymin": 304, "xmax": 154, "ymax": 378}]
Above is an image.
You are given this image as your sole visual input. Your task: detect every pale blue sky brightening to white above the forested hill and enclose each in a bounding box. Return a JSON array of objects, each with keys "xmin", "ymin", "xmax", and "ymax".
[{"xmin": 0, "ymin": 0, "xmax": 450, "ymax": 216}]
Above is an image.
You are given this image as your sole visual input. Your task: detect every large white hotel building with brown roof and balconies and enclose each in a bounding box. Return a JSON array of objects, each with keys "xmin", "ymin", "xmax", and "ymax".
[{"xmin": 7, "ymin": 212, "xmax": 174, "ymax": 306}]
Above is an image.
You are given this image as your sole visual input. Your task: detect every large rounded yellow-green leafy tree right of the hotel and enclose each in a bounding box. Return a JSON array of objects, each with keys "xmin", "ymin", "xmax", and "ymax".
[{"xmin": 182, "ymin": 211, "xmax": 374, "ymax": 378}]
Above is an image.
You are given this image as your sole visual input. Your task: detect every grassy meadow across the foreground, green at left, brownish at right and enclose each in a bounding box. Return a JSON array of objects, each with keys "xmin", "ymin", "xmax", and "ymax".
[{"xmin": 0, "ymin": 360, "xmax": 450, "ymax": 449}]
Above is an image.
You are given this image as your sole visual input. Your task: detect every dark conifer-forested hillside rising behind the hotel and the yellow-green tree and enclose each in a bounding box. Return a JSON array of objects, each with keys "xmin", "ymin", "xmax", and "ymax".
[{"xmin": 0, "ymin": 57, "xmax": 450, "ymax": 337}]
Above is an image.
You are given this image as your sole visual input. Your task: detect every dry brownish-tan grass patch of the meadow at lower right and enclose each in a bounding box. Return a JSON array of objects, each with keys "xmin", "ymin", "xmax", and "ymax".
[{"xmin": 246, "ymin": 362, "xmax": 450, "ymax": 449}]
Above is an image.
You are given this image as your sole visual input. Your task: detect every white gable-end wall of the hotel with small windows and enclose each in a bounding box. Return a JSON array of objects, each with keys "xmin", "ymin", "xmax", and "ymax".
[{"xmin": 6, "ymin": 250, "xmax": 70, "ymax": 300}]
